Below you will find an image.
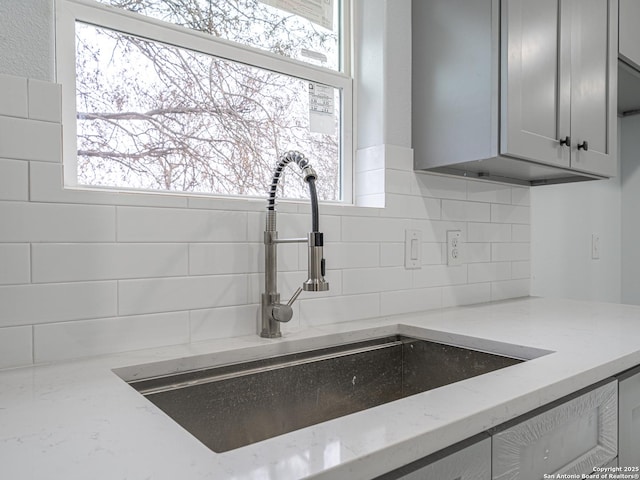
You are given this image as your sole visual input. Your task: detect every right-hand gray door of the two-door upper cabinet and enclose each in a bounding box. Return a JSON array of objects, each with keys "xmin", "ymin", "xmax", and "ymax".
[{"xmin": 564, "ymin": 0, "xmax": 618, "ymax": 177}]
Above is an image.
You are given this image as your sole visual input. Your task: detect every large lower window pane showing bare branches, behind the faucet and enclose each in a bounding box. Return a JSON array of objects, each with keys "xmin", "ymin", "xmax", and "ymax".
[{"xmin": 76, "ymin": 23, "xmax": 340, "ymax": 200}]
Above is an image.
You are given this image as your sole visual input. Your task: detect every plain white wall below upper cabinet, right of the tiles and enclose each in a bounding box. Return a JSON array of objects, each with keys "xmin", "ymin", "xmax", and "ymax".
[{"xmin": 531, "ymin": 122, "xmax": 626, "ymax": 303}]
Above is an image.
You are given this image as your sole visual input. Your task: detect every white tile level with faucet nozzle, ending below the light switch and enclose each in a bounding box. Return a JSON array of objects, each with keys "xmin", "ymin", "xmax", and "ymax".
[{"xmin": 342, "ymin": 267, "xmax": 412, "ymax": 295}]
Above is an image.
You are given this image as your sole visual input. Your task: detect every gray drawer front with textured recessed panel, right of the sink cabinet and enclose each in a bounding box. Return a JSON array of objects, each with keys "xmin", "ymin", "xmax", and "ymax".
[{"xmin": 492, "ymin": 380, "xmax": 618, "ymax": 480}]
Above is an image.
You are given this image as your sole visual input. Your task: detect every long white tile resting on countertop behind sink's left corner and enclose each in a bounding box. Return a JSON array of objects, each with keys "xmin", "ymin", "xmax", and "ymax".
[{"xmin": 33, "ymin": 312, "xmax": 189, "ymax": 363}]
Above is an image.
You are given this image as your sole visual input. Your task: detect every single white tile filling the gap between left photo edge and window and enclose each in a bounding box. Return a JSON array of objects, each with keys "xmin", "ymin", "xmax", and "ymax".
[{"xmin": 0, "ymin": 117, "xmax": 62, "ymax": 162}]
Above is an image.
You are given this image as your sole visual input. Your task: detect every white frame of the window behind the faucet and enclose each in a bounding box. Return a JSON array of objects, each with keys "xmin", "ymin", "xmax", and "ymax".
[{"xmin": 55, "ymin": 0, "xmax": 355, "ymax": 204}]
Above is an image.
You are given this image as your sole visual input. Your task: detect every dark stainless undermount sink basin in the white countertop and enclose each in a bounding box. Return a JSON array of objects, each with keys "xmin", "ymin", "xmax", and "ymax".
[{"xmin": 129, "ymin": 336, "xmax": 524, "ymax": 452}]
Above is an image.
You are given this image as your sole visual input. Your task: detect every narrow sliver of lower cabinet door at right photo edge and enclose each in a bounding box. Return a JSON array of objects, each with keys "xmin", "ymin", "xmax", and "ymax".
[{"xmin": 618, "ymin": 371, "xmax": 640, "ymax": 467}]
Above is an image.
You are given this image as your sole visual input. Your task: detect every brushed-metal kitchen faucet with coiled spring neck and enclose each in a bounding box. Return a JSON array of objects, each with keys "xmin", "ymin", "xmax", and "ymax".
[{"xmin": 260, "ymin": 151, "xmax": 329, "ymax": 338}]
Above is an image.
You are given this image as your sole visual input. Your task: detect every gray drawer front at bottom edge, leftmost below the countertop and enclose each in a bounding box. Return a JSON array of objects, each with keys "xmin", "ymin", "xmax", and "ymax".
[{"xmin": 390, "ymin": 437, "xmax": 491, "ymax": 480}]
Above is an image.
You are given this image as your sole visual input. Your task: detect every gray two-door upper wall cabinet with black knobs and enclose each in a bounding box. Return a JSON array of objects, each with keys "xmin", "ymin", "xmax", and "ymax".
[{"xmin": 412, "ymin": 0, "xmax": 618, "ymax": 185}]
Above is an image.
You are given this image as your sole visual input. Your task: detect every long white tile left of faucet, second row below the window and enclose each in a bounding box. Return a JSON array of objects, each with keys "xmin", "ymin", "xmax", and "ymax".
[{"xmin": 117, "ymin": 207, "xmax": 247, "ymax": 242}]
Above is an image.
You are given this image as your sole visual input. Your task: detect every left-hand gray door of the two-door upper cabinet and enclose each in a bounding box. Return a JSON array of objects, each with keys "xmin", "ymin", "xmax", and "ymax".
[{"xmin": 500, "ymin": 0, "xmax": 568, "ymax": 167}]
